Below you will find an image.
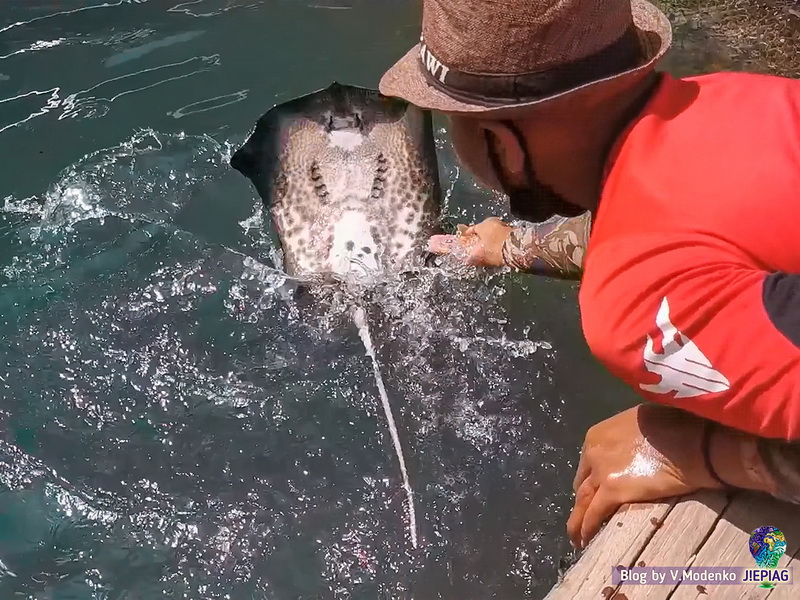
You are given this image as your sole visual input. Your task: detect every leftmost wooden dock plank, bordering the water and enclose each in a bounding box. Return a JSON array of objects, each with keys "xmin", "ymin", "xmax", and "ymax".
[{"xmin": 545, "ymin": 498, "xmax": 678, "ymax": 600}]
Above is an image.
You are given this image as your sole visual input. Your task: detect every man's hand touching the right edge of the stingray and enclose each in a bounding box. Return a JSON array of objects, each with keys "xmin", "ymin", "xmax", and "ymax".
[{"xmin": 428, "ymin": 217, "xmax": 512, "ymax": 267}]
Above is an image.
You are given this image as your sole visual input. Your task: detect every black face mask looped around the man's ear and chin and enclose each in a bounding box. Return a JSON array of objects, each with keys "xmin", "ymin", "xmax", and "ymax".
[{"xmin": 485, "ymin": 121, "xmax": 586, "ymax": 223}]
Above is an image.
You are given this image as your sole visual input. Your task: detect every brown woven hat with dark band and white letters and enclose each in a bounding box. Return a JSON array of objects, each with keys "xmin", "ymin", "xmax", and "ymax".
[{"xmin": 379, "ymin": 0, "xmax": 672, "ymax": 118}]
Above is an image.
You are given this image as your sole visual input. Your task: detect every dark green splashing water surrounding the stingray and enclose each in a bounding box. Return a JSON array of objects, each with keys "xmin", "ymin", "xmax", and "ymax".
[{"xmin": 0, "ymin": 0, "xmax": 792, "ymax": 600}]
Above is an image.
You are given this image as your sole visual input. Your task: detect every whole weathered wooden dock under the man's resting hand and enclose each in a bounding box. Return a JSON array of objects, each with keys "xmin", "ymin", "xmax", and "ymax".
[{"xmin": 545, "ymin": 491, "xmax": 800, "ymax": 600}]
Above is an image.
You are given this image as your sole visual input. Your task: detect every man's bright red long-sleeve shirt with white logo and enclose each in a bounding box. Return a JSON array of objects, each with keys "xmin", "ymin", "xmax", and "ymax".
[{"xmin": 580, "ymin": 73, "xmax": 800, "ymax": 439}]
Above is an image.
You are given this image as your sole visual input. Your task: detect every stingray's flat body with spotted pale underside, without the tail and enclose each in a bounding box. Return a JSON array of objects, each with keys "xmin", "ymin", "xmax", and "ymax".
[{"xmin": 231, "ymin": 83, "xmax": 441, "ymax": 279}]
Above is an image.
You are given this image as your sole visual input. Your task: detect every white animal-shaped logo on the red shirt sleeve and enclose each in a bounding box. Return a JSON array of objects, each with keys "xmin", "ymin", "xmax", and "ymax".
[{"xmin": 639, "ymin": 296, "xmax": 730, "ymax": 398}]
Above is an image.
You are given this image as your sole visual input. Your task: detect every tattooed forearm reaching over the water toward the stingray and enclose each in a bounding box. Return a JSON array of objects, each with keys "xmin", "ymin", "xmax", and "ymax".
[{"xmin": 503, "ymin": 212, "xmax": 592, "ymax": 279}]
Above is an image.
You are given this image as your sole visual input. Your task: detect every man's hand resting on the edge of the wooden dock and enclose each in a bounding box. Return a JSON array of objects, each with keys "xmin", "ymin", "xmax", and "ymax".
[{"xmin": 567, "ymin": 404, "xmax": 726, "ymax": 548}]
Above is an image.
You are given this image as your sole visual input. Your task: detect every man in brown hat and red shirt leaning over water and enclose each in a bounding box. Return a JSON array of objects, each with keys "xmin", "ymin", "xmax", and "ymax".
[{"xmin": 380, "ymin": 0, "xmax": 800, "ymax": 547}]
